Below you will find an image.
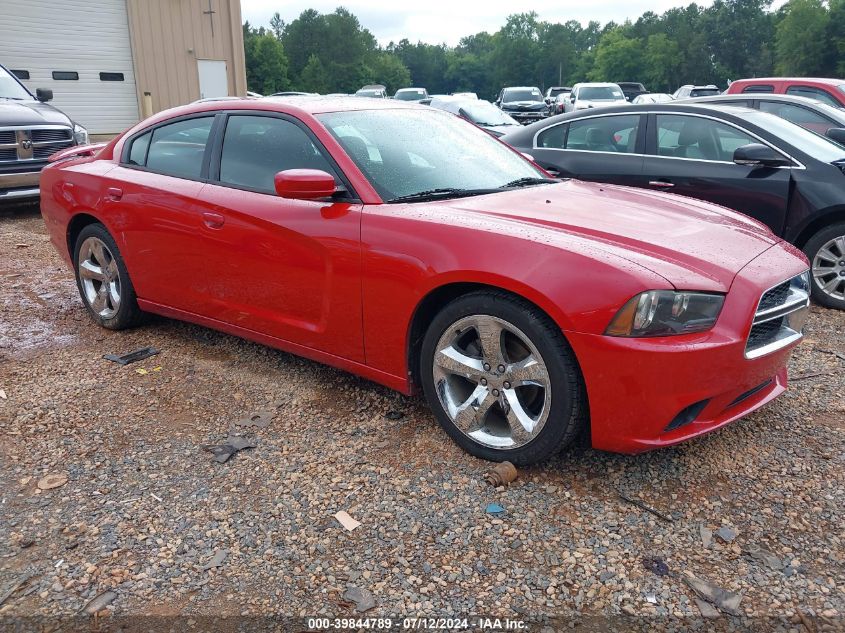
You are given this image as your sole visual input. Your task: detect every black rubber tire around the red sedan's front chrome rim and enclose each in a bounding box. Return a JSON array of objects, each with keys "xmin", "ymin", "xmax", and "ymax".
[{"xmin": 420, "ymin": 290, "xmax": 588, "ymax": 466}]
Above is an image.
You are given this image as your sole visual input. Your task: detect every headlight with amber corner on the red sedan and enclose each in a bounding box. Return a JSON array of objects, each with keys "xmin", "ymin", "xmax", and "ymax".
[{"xmin": 605, "ymin": 290, "xmax": 725, "ymax": 337}]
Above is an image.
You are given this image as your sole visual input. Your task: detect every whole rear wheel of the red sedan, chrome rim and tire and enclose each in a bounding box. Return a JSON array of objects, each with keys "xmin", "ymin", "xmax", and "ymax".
[{"xmin": 74, "ymin": 224, "xmax": 143, "ymax": 330}]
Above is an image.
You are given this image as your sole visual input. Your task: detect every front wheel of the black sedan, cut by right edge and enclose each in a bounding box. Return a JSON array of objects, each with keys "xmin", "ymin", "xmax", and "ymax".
[{"xmin": 804, "ymin": 222, "xmax": 845, "ymax": 310}]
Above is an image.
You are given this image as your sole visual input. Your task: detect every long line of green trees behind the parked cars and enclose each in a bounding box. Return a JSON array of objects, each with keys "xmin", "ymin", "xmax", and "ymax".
[{"xmin": 243, "ymin": 0, "xmax": 845, "ymax": 98}]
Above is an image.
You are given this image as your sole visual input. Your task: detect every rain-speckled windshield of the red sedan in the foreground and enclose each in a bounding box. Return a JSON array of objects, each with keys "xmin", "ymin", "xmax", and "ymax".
[{"xmin": 317, "ymin": 109, "xmax": 551, "ymax": 202}]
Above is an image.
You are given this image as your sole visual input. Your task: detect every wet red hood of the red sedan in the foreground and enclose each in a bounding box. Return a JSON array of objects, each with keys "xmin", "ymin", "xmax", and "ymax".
[{"xmin": 438, "ymin": 180, "xmax": 779, "ymax": 292}]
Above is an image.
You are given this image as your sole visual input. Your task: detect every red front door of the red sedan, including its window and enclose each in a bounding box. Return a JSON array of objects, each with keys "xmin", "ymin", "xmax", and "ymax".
[{"xmin": 191, "ymin": 113, "xmax": 364, "ymax": 362}]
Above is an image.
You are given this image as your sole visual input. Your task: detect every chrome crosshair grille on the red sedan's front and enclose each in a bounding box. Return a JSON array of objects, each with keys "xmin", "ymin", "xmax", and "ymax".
[{"xmin": 745, "ymin": 271, "xmax": 810, "ymax": 358}]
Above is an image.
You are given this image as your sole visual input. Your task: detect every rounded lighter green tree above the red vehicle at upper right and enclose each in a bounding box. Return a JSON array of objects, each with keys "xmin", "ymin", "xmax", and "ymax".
[{"xmin": 775, "ymin": 0, "xmax": 830, "ymax": 76}]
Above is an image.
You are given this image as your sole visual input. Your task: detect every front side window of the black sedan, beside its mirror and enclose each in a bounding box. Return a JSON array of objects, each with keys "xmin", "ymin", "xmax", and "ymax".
[{"xmin": 657, "ymin": 114, "xmax": 759, "ymax": 162}]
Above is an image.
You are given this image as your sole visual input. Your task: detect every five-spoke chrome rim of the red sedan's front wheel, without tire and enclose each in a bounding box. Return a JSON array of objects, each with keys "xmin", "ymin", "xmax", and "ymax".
[{"xmin": 432, "ymin": 315, "xmax": 552, "ymax": 449}]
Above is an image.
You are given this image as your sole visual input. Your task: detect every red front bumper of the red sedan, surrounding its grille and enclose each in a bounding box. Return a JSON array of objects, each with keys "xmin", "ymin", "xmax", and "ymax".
[{"xmin": 566, "ymin": 244, "xmax": 807, "ymax": 454}]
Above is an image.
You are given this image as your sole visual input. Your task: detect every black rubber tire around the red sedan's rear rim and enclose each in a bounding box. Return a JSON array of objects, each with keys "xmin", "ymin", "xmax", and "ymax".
[{"xmin": 73, "ymin": 224, "xmax": 144, "ymax": 330}]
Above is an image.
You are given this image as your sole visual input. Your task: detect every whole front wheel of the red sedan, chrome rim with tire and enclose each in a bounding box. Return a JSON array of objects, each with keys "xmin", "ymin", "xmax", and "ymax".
[{"xmin": 420, "ymin": 291, "xmax": 586, "ymax": 465}]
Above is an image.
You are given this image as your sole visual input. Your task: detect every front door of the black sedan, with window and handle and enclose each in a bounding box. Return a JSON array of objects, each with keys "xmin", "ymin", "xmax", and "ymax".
[{"xmin": 638, "ymin": 113, "xmax": 791, "ymax": 234}]
